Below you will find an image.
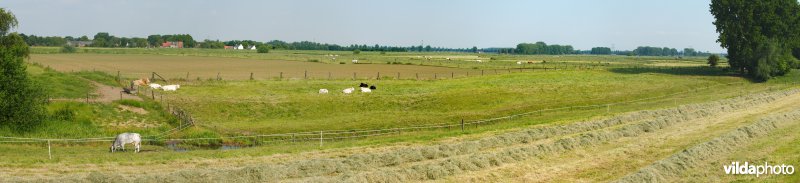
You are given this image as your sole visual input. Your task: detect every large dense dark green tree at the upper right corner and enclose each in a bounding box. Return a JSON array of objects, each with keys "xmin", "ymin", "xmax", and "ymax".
[{"xmin": 710, "ymin": 0, "xmax": 800, "ymax": 81}]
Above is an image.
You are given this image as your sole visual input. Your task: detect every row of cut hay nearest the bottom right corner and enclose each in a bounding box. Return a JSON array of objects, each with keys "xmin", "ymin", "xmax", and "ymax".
[{"xmin": 616, "ymin": 110, "xmax": 800, "ymax": 182}]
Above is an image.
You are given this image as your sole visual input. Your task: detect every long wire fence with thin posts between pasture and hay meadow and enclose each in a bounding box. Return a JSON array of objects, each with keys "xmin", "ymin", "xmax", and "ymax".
[{"xmin": 0, "ymin": 82, "xmax": 772, "ymax": 152}]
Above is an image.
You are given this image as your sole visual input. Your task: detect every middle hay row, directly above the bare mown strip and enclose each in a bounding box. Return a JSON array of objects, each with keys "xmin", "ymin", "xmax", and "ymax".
[{"xmin": 324, "ymin": 89, "xmax": 800, "ymax": 182}]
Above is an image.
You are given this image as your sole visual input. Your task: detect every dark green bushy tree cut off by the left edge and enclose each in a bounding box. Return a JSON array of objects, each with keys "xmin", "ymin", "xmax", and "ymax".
[{"xmin": 0, "ymin": 8, "xmax": 46, "ymax": 132}]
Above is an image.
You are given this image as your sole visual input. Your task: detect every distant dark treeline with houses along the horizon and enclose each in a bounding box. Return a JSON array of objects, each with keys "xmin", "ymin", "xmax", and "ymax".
[{"xmin": 21, "ymin": 32, "xmax": 710, "ymax": 56}]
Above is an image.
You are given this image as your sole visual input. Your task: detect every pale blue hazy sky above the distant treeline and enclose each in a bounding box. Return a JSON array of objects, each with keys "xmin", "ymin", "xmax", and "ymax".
[{"xmin": 0, "ymin": 0, "xmax": 724, "ymax": 52}]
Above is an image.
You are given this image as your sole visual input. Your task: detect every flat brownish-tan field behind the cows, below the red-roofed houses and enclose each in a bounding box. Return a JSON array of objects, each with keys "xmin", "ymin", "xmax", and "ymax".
[{"xmin": 30, "ymin": 54, "xmax": 472, "ymax": 80}]
